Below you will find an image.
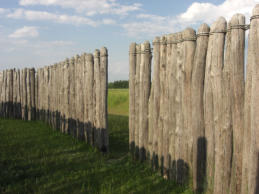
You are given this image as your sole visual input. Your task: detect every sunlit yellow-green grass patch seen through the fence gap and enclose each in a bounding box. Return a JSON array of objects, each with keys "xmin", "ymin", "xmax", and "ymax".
[{"xmin": 108, "ymin": 89, "xmax": 129, "ymax": 116}]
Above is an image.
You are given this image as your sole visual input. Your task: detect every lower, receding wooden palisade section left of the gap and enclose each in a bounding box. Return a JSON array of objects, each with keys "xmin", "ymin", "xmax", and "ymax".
[{"xmin": 0, "ymin": 47, "xmax": 109, "ymax": 152}]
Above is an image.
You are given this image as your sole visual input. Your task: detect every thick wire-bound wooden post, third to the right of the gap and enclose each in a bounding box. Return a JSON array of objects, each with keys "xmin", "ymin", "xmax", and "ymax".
[{"xmin": 139, "ymin": 41, "xmax": 151, "ymax": 161}]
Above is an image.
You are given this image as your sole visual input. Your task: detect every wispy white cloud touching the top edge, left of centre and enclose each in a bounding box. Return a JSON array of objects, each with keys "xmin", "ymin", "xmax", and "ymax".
[{"xmin": 19, "ymin": 0, "xmax": 141, "ymax": 16}]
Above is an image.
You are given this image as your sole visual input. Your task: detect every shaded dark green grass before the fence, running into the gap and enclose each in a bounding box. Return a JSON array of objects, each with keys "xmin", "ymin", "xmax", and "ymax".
[{"xmin": 0, "ymin": 90, "xmax": 192, "ymax": 194}]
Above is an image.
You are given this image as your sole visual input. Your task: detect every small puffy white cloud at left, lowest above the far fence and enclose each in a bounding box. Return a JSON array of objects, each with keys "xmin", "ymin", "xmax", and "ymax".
[{"xmin": 9, "ymin": 26, "xmax": 39, "ymax": 38}]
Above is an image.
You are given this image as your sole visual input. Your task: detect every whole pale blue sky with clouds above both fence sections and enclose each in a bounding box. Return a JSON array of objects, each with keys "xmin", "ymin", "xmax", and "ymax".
[{"xmin": 0, "ymin": 0, "xmax": 259, "ymax": 81}]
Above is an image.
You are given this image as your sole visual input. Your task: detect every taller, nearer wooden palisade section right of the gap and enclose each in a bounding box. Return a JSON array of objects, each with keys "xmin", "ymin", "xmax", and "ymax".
[{"xmin": 129, "ymin": 5, "xmax": 259, "ymax": 194}]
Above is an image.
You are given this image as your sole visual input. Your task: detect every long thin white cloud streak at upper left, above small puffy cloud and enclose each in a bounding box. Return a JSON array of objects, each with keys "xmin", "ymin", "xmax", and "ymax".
[{"xmin": 7, "ymin": 9, "xmax": 97, "ymax": 26}]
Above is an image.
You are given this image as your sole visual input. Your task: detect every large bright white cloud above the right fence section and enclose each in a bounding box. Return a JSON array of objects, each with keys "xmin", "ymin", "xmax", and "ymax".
[{"xmin": 122, "ymin": 0, "xmax": 259, "ymax": 38}]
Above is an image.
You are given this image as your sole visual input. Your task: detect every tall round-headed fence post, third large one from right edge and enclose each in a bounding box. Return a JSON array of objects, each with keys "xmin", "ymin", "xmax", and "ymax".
[{"xmin": 210, "ymin": 17, "xmax": 227, "ymax": 193}]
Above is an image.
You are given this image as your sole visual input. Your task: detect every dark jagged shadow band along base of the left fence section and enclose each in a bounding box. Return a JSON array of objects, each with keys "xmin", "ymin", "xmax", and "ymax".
[{"xmin": 0, "ymin": 102, "xmax": 108, "ymax": 153}]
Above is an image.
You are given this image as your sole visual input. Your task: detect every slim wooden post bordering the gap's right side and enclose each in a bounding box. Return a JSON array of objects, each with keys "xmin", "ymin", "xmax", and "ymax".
[{"xmin": 129, "ymin": 43, "xmax": 137, "ymax": 152}]
